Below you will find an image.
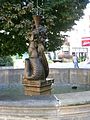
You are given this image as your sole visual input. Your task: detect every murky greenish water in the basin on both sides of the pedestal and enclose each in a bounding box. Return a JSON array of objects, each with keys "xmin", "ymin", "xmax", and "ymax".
[{"xmin": 0, "ymin": 83, "xmax": 90, "ymax": 100}]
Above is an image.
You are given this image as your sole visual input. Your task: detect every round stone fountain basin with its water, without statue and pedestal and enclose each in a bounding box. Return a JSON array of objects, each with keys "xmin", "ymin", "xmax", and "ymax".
[{"xmin": 0, "ymin": 69, "xmax": 90, "ymax": 120}]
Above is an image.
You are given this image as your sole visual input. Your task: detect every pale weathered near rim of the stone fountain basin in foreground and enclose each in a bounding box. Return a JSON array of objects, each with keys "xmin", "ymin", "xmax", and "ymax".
[{"xmin": 0, "ymin": 91, "xmax": 90, "ymax": 120}]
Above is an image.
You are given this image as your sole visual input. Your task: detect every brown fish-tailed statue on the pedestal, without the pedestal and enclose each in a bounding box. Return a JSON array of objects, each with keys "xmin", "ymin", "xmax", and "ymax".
[{"xmin": 24, "ymin": 15, "xmax": 49, "ymax": 80}]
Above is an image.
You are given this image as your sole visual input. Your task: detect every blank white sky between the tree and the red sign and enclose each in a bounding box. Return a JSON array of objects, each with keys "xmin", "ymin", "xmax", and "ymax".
[{"xmin": 67, "ymin": 3, "xmax": 90, "ymax": 47}]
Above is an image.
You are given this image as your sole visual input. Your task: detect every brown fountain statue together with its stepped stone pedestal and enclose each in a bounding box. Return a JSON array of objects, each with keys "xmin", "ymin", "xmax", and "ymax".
[{"xmin": 22, "ymin": 0, "xmax": 54, "ymax": 95}]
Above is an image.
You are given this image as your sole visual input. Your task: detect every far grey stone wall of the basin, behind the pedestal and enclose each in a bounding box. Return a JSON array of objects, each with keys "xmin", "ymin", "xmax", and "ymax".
[{"xmin": 0, "ymin": 68, "xmax": 90, "ymax": 86}]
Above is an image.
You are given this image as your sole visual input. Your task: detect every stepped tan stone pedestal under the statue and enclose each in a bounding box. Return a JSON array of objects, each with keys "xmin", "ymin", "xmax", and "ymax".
[{"xmin": 23, "ymin": 79, "xmax": 54, "ymax": 95}]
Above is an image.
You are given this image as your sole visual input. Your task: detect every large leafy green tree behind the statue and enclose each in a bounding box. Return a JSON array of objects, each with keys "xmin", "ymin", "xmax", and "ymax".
[{"xmin": 0, "ymin": 0, "xmax": 89, "ymax": 55}]
